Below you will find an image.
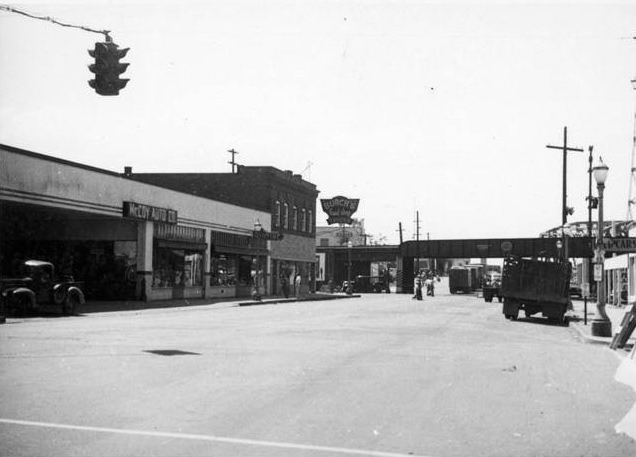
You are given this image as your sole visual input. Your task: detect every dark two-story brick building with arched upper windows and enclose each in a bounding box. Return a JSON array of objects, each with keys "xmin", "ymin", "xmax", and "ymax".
[{"xmin": 127, "ymin": 165, "xmax": 319, "ymax": 294}]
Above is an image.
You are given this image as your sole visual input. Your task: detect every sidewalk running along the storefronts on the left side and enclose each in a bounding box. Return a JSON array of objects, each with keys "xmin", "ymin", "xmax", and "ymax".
[{"xmin": 79, "ymin": 293, "xmax": 360, "ymax": 314}]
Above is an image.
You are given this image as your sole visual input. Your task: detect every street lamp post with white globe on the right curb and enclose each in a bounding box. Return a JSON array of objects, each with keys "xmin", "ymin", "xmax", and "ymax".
[{"xmin": 592, "ymin": 157, "xmax": 612, "ymax": 337}]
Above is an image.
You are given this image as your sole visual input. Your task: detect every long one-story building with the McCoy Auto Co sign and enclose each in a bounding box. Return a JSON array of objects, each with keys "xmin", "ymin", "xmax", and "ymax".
[{"xmin": 0, "ymin": 145, "xmax": 271, "ymax": 301}]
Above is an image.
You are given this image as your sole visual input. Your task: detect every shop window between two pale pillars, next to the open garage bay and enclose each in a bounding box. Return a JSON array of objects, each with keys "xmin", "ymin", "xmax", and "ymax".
[{"xmin": 152, "ymin": 246, "xmax": 203, "ymax": 287}]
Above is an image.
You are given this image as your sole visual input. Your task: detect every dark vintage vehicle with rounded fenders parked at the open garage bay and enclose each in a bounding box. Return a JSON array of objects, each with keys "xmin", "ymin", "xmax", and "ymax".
[{"xmin": 0, "ymin": 260, "xmax": 85, "ymax": 315}]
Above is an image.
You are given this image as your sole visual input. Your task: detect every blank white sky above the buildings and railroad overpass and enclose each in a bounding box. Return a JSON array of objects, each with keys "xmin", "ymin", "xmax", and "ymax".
[{"xmin": 0, "ymin": 0, "xmax": 636, "ymax": 243}]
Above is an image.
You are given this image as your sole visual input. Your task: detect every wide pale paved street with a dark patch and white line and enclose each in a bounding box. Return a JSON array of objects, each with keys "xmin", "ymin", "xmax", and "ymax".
[{"xmin": 0, "ymin": 290, "xmax": 636, "ymax": 457}]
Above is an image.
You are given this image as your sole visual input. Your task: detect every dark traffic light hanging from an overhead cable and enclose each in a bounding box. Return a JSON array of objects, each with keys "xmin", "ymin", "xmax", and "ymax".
[{"xmin": 88, "ymin": 37, "xmax": 130, "ymax": 95}]
